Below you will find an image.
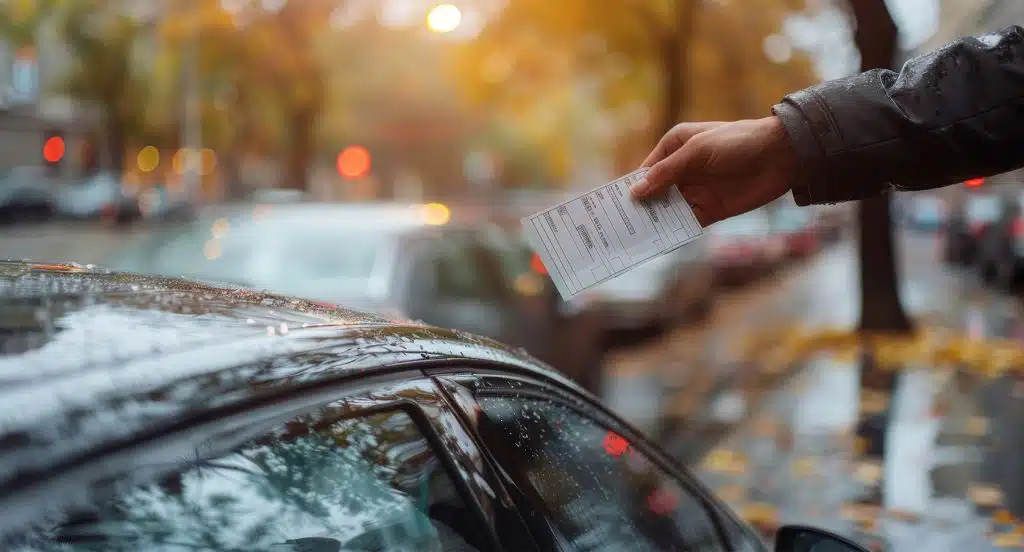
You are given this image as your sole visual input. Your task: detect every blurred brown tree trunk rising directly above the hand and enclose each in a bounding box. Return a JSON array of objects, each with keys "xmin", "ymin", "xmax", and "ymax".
[{"xmin": 657, "ymin": 0, "xmax": 697, "ymax": 138}]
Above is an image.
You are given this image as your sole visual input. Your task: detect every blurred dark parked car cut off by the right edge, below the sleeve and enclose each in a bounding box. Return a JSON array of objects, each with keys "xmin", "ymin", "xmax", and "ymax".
[{"xmin": 977, "ymin": 192, "xmax": 1024, "ymax": 292}]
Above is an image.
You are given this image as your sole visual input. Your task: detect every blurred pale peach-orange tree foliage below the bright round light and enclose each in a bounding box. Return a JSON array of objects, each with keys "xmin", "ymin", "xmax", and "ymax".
[{"xmin": 321, "ymin": 17, "xmax": 480, "ymax": 196}]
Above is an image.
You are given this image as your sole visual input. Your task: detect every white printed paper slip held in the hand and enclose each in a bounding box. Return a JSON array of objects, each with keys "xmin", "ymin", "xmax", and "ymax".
[{"xmin": 522, "ymin": 168, "xmax": 703, "ymax": 301}]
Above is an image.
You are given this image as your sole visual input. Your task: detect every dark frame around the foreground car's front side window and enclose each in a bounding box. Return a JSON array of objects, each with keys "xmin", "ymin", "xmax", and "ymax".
[{"xmin": 424, "ymin": 362, "xmax": 764, "ymax": 550}]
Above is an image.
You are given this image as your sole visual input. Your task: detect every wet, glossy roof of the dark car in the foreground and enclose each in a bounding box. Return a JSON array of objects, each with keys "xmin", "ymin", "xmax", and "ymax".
[{"xmin": 0, "ymin": 261, "xmax": 579, "ymax": 489}]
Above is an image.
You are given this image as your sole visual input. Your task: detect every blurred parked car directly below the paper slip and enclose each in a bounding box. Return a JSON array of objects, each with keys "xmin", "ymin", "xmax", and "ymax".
[{"xmin": 584, "ymin": 240, "xmax": 715, "ymax": 332}]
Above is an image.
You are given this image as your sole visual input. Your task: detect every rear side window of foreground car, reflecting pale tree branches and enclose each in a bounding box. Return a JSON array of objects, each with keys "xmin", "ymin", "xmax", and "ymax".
[{"xmin": 11, "ymin": 409, "xmax": 489, "ymax": 552}]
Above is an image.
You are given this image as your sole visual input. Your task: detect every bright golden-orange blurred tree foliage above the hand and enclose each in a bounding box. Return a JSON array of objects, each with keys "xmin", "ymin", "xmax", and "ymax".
[{"xmin": 460, "ymin": 0, "xmax": 813, "ymax": 181}]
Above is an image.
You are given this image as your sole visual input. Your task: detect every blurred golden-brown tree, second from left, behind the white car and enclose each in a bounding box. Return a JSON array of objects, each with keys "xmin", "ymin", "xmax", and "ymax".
[{"xmin": 156, "ymin": 0, "xmax": 331, "ymax": 195}]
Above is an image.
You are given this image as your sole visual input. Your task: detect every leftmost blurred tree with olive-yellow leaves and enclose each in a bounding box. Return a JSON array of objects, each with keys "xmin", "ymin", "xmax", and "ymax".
[{"xmin": 58, "ymin": 0, "xmax": 148, "ymax": 173}]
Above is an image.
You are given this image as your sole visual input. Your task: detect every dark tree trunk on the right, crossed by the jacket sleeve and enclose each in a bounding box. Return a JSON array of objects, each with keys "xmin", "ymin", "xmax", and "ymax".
[{"xmin": 850, "ymin": 0, "xmax": 912, "ymax": 333}]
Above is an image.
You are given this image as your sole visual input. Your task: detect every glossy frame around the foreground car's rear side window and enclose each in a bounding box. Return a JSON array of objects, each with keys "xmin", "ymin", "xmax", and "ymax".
[{"xmin": 6, "ymin": 362, "xmax": 537, "ymax": 552}]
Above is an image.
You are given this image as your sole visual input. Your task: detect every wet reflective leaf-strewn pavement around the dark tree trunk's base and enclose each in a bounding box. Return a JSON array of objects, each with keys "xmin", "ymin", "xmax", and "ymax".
[{"xmin": 607, "ymin": 231, "xmax": 1024, "ymax": 552}]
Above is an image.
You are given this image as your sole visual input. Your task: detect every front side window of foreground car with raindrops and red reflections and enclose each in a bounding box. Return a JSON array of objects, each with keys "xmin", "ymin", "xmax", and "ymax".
[{"xmin": 477, "ymin": 394, "xmax": 759, "ymax": 552}]
